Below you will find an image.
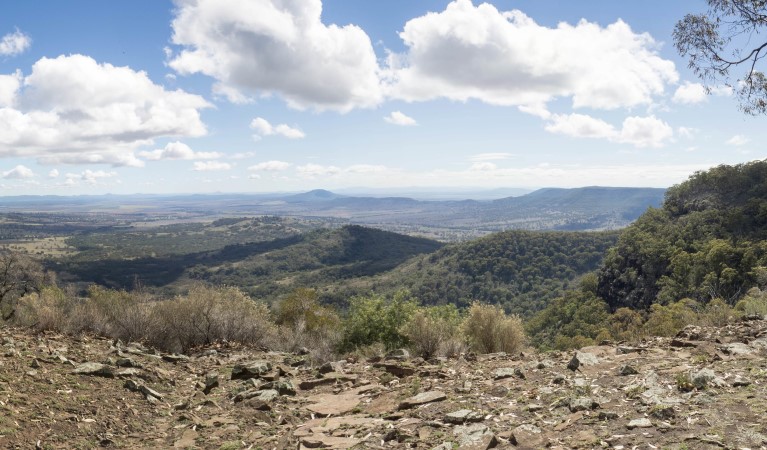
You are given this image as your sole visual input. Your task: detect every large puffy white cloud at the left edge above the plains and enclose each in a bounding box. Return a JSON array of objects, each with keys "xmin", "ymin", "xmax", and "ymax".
[{"xmin": 0, "ymin": 55, "xmax": 211, "ymax": 166}]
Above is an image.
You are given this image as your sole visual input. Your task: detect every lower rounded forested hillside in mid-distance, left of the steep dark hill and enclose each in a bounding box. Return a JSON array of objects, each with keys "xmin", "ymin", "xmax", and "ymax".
[{"xmin": 375, "ymin": 231, "xmax": 618, "ymax": 315}]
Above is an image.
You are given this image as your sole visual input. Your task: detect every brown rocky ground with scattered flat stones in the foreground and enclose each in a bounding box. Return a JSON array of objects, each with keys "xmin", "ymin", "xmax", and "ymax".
[{"xmin": 0, "ymin": 320, "xmax": 767, "ymax": 450}]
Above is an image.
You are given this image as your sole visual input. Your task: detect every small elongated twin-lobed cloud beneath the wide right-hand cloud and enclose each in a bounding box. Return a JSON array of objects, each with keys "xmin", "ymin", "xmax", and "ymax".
[{"xmin": 546, "ymin": 114, "xmax": 674, "ymax": 148}]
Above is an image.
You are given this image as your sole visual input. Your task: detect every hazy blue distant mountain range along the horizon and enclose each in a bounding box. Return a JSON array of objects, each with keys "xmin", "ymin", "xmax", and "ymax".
[{"xmin": 0, "ymin": 186, "xmax": 665, "ymax": 234}]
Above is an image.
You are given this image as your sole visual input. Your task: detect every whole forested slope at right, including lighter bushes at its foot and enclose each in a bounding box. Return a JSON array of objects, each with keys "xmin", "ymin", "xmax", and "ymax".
[{"xmin": 527, "ymin": 161, "xmax": 767, "ymax": 348}]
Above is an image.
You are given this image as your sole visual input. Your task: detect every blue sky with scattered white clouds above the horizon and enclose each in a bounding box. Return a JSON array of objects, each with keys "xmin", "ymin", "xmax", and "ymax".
[{"xmin": 0, "ymin": 0, "xmax": 767, "ymax": 196}]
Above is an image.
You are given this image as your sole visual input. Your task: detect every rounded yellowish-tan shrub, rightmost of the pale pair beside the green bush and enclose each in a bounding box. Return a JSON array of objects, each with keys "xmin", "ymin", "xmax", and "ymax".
[{"xmin": 462, "ymin": 302, "xmax": 526, "ymax": 353}]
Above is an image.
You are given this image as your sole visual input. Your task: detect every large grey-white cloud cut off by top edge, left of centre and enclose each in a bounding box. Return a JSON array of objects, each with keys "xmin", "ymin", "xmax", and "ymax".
[{"xmin": 169, "ymin": 0, "xmax": 382, "ymax": 111}]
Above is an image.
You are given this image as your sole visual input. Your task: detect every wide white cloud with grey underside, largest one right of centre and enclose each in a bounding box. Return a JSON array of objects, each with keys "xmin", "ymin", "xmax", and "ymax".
[{"xmin": 388, "ymin": 0, "xmax": 679, "ymax": 110}]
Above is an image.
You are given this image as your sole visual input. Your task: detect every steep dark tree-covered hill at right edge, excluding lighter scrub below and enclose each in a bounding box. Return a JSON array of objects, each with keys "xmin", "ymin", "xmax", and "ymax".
[{"xmin": 597, "ymin": 161, "xmax": 767, "ymax": 310}]
